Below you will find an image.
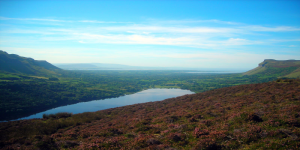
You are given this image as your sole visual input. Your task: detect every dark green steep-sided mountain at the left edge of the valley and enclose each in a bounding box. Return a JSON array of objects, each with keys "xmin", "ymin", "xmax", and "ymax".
[{"xmin": 0, "ymin": 50, "xmax": 61, "ymax": 75}]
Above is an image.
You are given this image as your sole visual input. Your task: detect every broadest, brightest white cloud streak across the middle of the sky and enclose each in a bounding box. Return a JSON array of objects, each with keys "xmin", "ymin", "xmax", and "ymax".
[{"xmin": 68, "ymin": 33, "xmax": 262, "ymax": 48}]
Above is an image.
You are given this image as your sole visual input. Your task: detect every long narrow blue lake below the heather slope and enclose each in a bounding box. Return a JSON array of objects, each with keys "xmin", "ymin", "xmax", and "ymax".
[{"xmin": 17, "ymin": 89, "xmax": 194, "ymax": 120}]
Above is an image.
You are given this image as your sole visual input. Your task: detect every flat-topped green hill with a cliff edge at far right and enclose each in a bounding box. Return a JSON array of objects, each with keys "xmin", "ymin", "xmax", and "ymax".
[{"xmin": 244, "ymin": 59, "xmax": 300, "ymax": 78}]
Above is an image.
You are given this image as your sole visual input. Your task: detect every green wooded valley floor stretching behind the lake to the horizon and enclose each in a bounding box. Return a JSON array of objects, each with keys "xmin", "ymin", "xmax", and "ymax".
[{"xmin": 0, "ymin": 70, "xmax": 277, "ymax": 121}]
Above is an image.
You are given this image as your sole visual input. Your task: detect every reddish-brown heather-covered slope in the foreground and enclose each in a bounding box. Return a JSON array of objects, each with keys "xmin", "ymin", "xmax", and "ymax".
[{"xmin": 0, "ymin": 79, "xmax": 300, "ymax": 149}]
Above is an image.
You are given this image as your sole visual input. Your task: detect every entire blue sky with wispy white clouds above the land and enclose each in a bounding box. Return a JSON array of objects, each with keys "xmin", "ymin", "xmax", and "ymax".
[{"xmin": 0, "ymin": 0, "xmax": 300, "ymax": 69}]
